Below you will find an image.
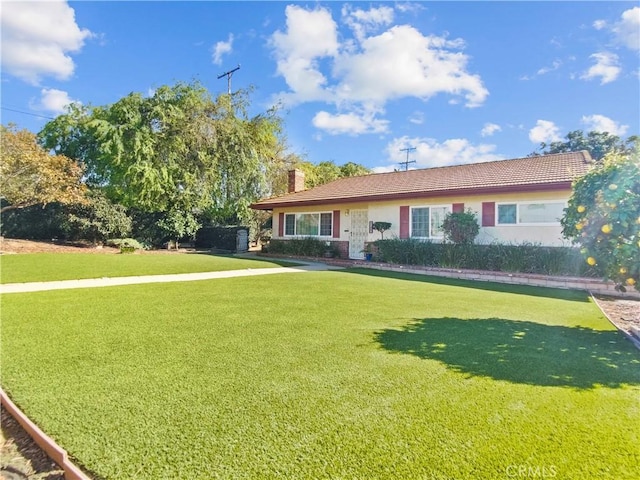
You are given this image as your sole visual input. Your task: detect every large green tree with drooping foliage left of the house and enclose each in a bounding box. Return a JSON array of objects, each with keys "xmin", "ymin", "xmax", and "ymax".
[{"xmin": 39, "ymin": 82, "xmax": 282, "ymax": 244}]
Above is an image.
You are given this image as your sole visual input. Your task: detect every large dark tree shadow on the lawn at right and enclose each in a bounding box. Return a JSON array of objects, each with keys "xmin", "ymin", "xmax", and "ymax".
[{"xmin": 376, "ymin": 318, "xmax": 640, "ymax": 388}]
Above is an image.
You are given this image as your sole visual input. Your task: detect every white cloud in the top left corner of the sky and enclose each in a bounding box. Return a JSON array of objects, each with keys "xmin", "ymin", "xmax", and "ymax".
[{"xmin": 0, "ymin": 1, "xmax": 92, "ymax": 85}]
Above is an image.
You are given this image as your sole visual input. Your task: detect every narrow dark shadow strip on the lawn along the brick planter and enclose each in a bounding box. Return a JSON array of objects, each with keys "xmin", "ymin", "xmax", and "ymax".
[{"xmin": 341, "ymin": 268, "xmax": 589, "ymax": 302}]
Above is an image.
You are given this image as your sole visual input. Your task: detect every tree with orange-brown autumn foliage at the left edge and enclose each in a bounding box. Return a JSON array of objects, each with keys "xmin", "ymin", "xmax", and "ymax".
[{"xmin": 0, "ymin": 125, "xmax": 86, "ymax": 213}]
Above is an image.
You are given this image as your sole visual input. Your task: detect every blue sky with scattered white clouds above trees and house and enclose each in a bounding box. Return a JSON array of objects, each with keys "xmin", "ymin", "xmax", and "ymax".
[{"xmin": 0, "ymin": 0, "xmax": 640, "ymax": 171}]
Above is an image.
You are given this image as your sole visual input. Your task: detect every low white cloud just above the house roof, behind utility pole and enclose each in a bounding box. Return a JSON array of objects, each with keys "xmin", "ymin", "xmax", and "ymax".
[{"xmin": 374, "ymin": 136, "xmax": 504, "ymax": 172}]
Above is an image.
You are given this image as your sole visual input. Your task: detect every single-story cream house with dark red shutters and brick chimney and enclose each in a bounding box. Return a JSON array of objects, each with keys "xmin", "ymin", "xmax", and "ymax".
[{"xmin": 251, "ymin": 151, "xmax": 592, "ymax": 258}]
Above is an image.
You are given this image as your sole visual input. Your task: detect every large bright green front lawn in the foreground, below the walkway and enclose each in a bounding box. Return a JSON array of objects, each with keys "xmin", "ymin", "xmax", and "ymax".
[{"xmin": 1, "ymin": 264, "xmax": 640, "ymax": 480}]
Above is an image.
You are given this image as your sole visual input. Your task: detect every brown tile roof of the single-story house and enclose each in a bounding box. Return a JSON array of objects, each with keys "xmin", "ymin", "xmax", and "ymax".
[{"xmin": 251, "ymin": 151, "xmax": 592, "ymax": 210}]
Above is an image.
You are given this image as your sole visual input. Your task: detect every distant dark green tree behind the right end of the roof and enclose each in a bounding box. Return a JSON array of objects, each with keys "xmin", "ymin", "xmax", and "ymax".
[{"xmin": 531, "ymin": 130, "xmax": 640, "ymax": 161}]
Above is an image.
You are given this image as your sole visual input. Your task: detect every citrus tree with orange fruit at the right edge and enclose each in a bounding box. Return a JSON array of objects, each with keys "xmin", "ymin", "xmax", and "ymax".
[{"xmin": 562, "ymin": 150, "xmax": 640, "ymax": 291}]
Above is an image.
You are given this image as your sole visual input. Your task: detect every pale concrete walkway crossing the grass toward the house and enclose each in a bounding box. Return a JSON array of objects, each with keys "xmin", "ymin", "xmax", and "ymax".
[{"xmin": 0, "ymin": 262, "xmax": 342, "ymax": 294}]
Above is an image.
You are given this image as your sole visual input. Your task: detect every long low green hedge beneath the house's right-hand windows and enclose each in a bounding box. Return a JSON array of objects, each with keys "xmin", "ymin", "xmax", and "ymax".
[{"xmin": 375, "ymin": 239, "xmax": 602, "ymax": 277}]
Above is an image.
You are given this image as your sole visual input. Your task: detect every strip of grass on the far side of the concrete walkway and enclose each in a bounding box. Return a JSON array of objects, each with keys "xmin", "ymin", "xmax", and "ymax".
[{"xmin": 0, "ymin": 253, "xmax": 294, "ymax": 283}]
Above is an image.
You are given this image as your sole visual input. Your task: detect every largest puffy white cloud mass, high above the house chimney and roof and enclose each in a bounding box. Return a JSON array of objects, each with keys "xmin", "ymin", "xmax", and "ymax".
[{"xmin": 270, "ymin": 5, "xmax": 489, "ymax": 131}]
